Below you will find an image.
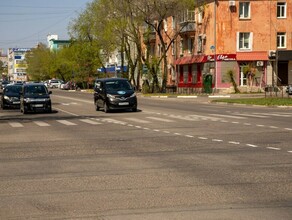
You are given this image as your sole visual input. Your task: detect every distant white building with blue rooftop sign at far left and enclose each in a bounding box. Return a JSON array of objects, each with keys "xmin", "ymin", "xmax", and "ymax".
[{"xmin": 7, "ymin": 48, "xmax": 31, "ymax": 81}]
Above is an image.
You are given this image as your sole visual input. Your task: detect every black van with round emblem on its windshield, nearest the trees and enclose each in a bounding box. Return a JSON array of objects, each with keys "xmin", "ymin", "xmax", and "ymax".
[{"xmin": 94, "ymin": 78, "xmax": 137, "ymax": 113}]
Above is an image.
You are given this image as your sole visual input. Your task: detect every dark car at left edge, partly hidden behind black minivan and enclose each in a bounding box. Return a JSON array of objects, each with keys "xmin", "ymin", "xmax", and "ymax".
[{"xmin": 0, "ymin": 84, "xmax": 22, "ymax": 109}]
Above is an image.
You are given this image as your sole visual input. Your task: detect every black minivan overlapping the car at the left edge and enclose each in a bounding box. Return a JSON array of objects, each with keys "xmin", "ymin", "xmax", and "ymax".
[{"xmin": 20, "ymin": 83, "xmax": 52, "ymax": 114}]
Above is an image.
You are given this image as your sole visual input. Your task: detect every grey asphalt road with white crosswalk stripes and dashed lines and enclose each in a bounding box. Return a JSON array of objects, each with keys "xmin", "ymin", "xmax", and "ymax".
[{"xmin": 0, "ymin": 90, "xmax": 292, "ymax": 220}]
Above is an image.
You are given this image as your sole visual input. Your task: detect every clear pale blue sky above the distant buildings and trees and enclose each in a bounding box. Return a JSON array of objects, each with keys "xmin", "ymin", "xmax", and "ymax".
[{"xmin": 0, "ymin": 0, "xmax": 92, "ymax": 54}]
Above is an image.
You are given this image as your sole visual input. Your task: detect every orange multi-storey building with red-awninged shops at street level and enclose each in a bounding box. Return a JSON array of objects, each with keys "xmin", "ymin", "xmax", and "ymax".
[{"xmin": 143, "ymin": 0, "xmax": 292, "ymax": 93}]
